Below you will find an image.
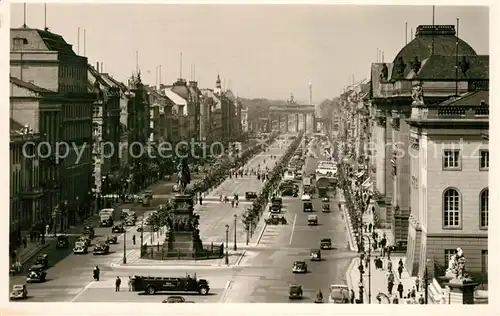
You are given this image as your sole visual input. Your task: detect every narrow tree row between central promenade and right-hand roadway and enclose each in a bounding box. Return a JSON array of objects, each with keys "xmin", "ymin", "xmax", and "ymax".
[{"xmin": 241, "ymin": 132, "xmax": 303, "ymax": 237}]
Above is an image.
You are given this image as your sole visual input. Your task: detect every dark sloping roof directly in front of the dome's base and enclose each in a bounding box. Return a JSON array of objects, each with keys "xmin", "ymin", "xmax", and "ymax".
[{"xmin": 406, "ymin": 55, "xmax": 490, "ymax": 80}]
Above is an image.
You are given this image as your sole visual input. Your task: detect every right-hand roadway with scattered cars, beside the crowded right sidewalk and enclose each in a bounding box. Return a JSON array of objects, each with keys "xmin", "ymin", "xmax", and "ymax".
[{"xmin": 219, "ymin": 137, "xmax": 356, "ymax": 303}]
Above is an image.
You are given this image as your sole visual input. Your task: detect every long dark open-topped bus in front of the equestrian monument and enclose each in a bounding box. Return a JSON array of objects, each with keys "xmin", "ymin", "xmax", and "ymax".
[{"xmin": 132, "ymin": 274, "xmax": 210, "ymax": 295}]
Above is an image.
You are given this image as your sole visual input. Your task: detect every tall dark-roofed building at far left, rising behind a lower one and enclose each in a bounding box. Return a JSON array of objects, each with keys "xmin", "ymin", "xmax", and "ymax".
[{"xmin": 10, "ymin": 27, "xmax": 95, "ymax": 227}]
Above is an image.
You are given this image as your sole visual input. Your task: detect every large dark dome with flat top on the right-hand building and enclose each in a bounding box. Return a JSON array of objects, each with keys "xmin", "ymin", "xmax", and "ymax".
[{"xmin": 391, "ymin": 25, "xmax": 477, "ymax": 79}]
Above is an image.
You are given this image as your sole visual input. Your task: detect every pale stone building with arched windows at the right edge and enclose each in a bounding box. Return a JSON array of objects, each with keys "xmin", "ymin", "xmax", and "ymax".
[{"xmin": 406, "ymin": 88, "xmax": 489, "ymax": 276}]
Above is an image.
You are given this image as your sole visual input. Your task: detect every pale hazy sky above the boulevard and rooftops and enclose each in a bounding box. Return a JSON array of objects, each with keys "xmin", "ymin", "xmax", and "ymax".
[{"xmin": 11, "ymin": 3, "xmax": 489, "ymax": 104}]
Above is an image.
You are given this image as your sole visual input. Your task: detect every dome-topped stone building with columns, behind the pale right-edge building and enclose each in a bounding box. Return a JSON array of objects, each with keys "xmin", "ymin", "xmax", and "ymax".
[{"xmin": 371, "ymin": 25, "xmax": 489, "ymax": 275}]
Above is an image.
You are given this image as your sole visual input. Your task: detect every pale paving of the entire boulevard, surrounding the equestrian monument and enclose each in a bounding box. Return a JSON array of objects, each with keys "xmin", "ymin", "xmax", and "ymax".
[{"xmin": 10, "ymin": 136, "xmax": 355, "ymax": 303}]
